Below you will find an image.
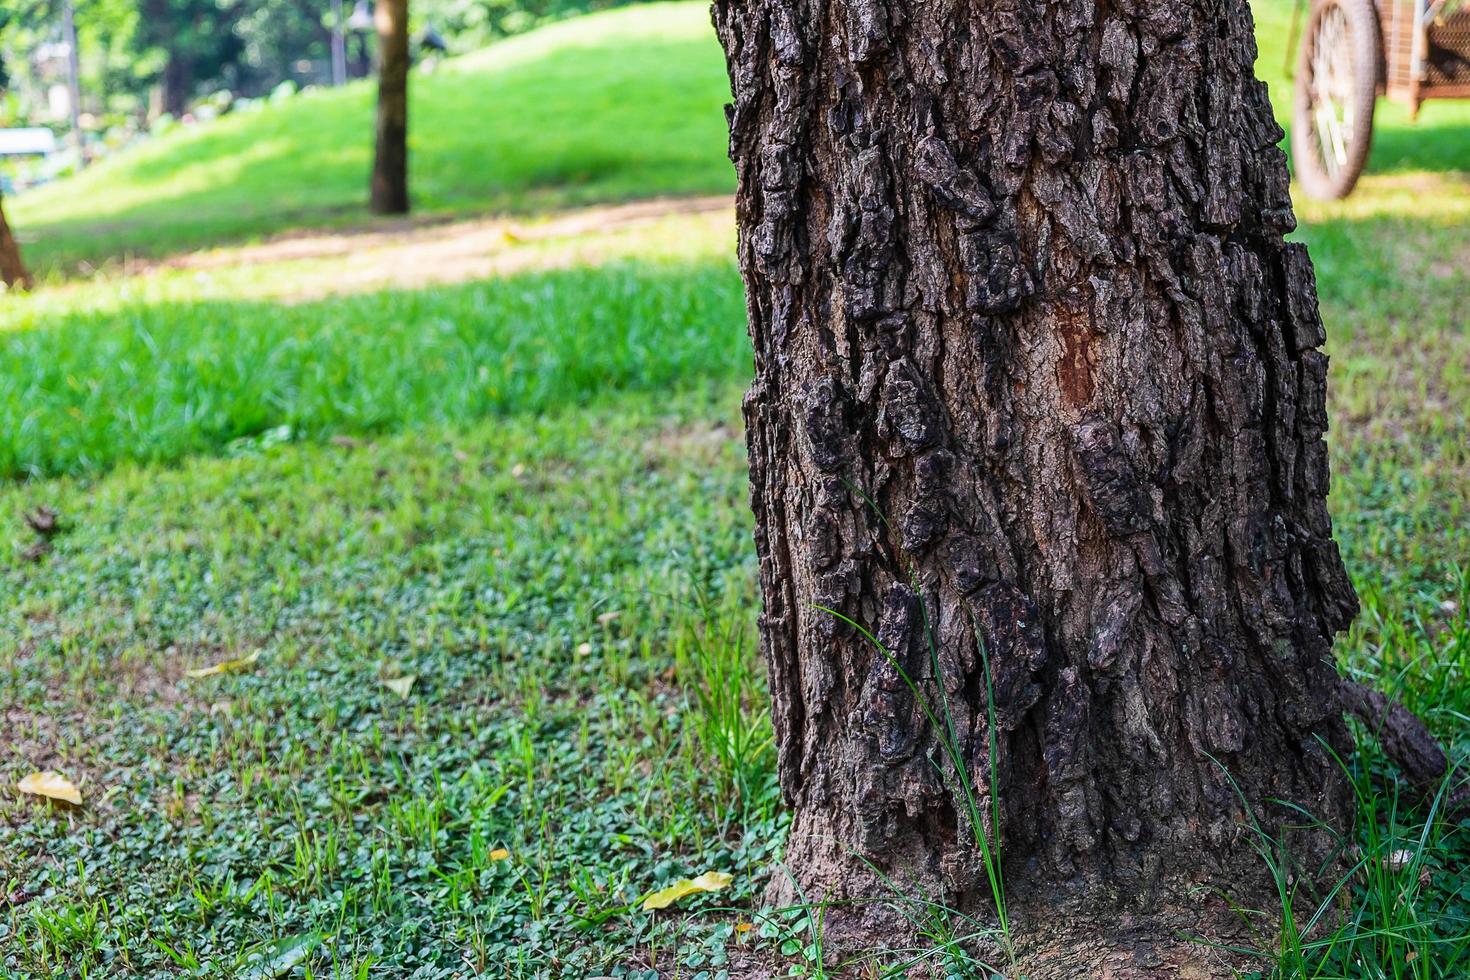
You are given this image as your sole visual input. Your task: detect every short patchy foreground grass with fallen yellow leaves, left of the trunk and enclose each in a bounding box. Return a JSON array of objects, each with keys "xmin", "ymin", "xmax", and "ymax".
[{"xmin": 0, "ymin": 386, "xmax": 782, "ymax": 977}]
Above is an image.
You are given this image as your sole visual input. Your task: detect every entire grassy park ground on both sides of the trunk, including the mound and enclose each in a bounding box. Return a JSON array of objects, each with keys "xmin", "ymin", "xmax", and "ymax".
[{"xmin": 0, "ymin": 4, "xmax": 1470, "ymax": 980}]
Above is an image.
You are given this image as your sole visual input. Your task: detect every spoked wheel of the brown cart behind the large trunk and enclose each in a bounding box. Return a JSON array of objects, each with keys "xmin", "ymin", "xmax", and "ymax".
[{"xmin": 1291, "ymin": 0, "xmax": 1382, "ymax": 200}]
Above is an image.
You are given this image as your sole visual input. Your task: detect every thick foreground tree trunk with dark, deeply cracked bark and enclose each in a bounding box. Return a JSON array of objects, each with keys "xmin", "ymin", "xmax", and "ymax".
[{"xmin": 714, "ymin": 0, "xmax": 1357, "ymax": 977}]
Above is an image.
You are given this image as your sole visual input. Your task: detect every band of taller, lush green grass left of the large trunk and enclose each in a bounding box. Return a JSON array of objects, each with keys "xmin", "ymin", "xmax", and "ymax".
[{"xmin": 0, "ymin": 260, "xmax": 750, "ymax": 478}]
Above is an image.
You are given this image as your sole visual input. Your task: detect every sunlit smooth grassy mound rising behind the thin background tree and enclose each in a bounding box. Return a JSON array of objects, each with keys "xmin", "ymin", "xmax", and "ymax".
[{"xmin": 6, "ymin": 3, "xmax": 735, "ymax": 273}]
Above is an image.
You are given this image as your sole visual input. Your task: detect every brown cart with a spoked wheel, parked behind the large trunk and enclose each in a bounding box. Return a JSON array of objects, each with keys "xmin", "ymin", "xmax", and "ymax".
[{"xmin": 1292, "ymin": 0, "xmax": 1470, "ymax": 198}]
